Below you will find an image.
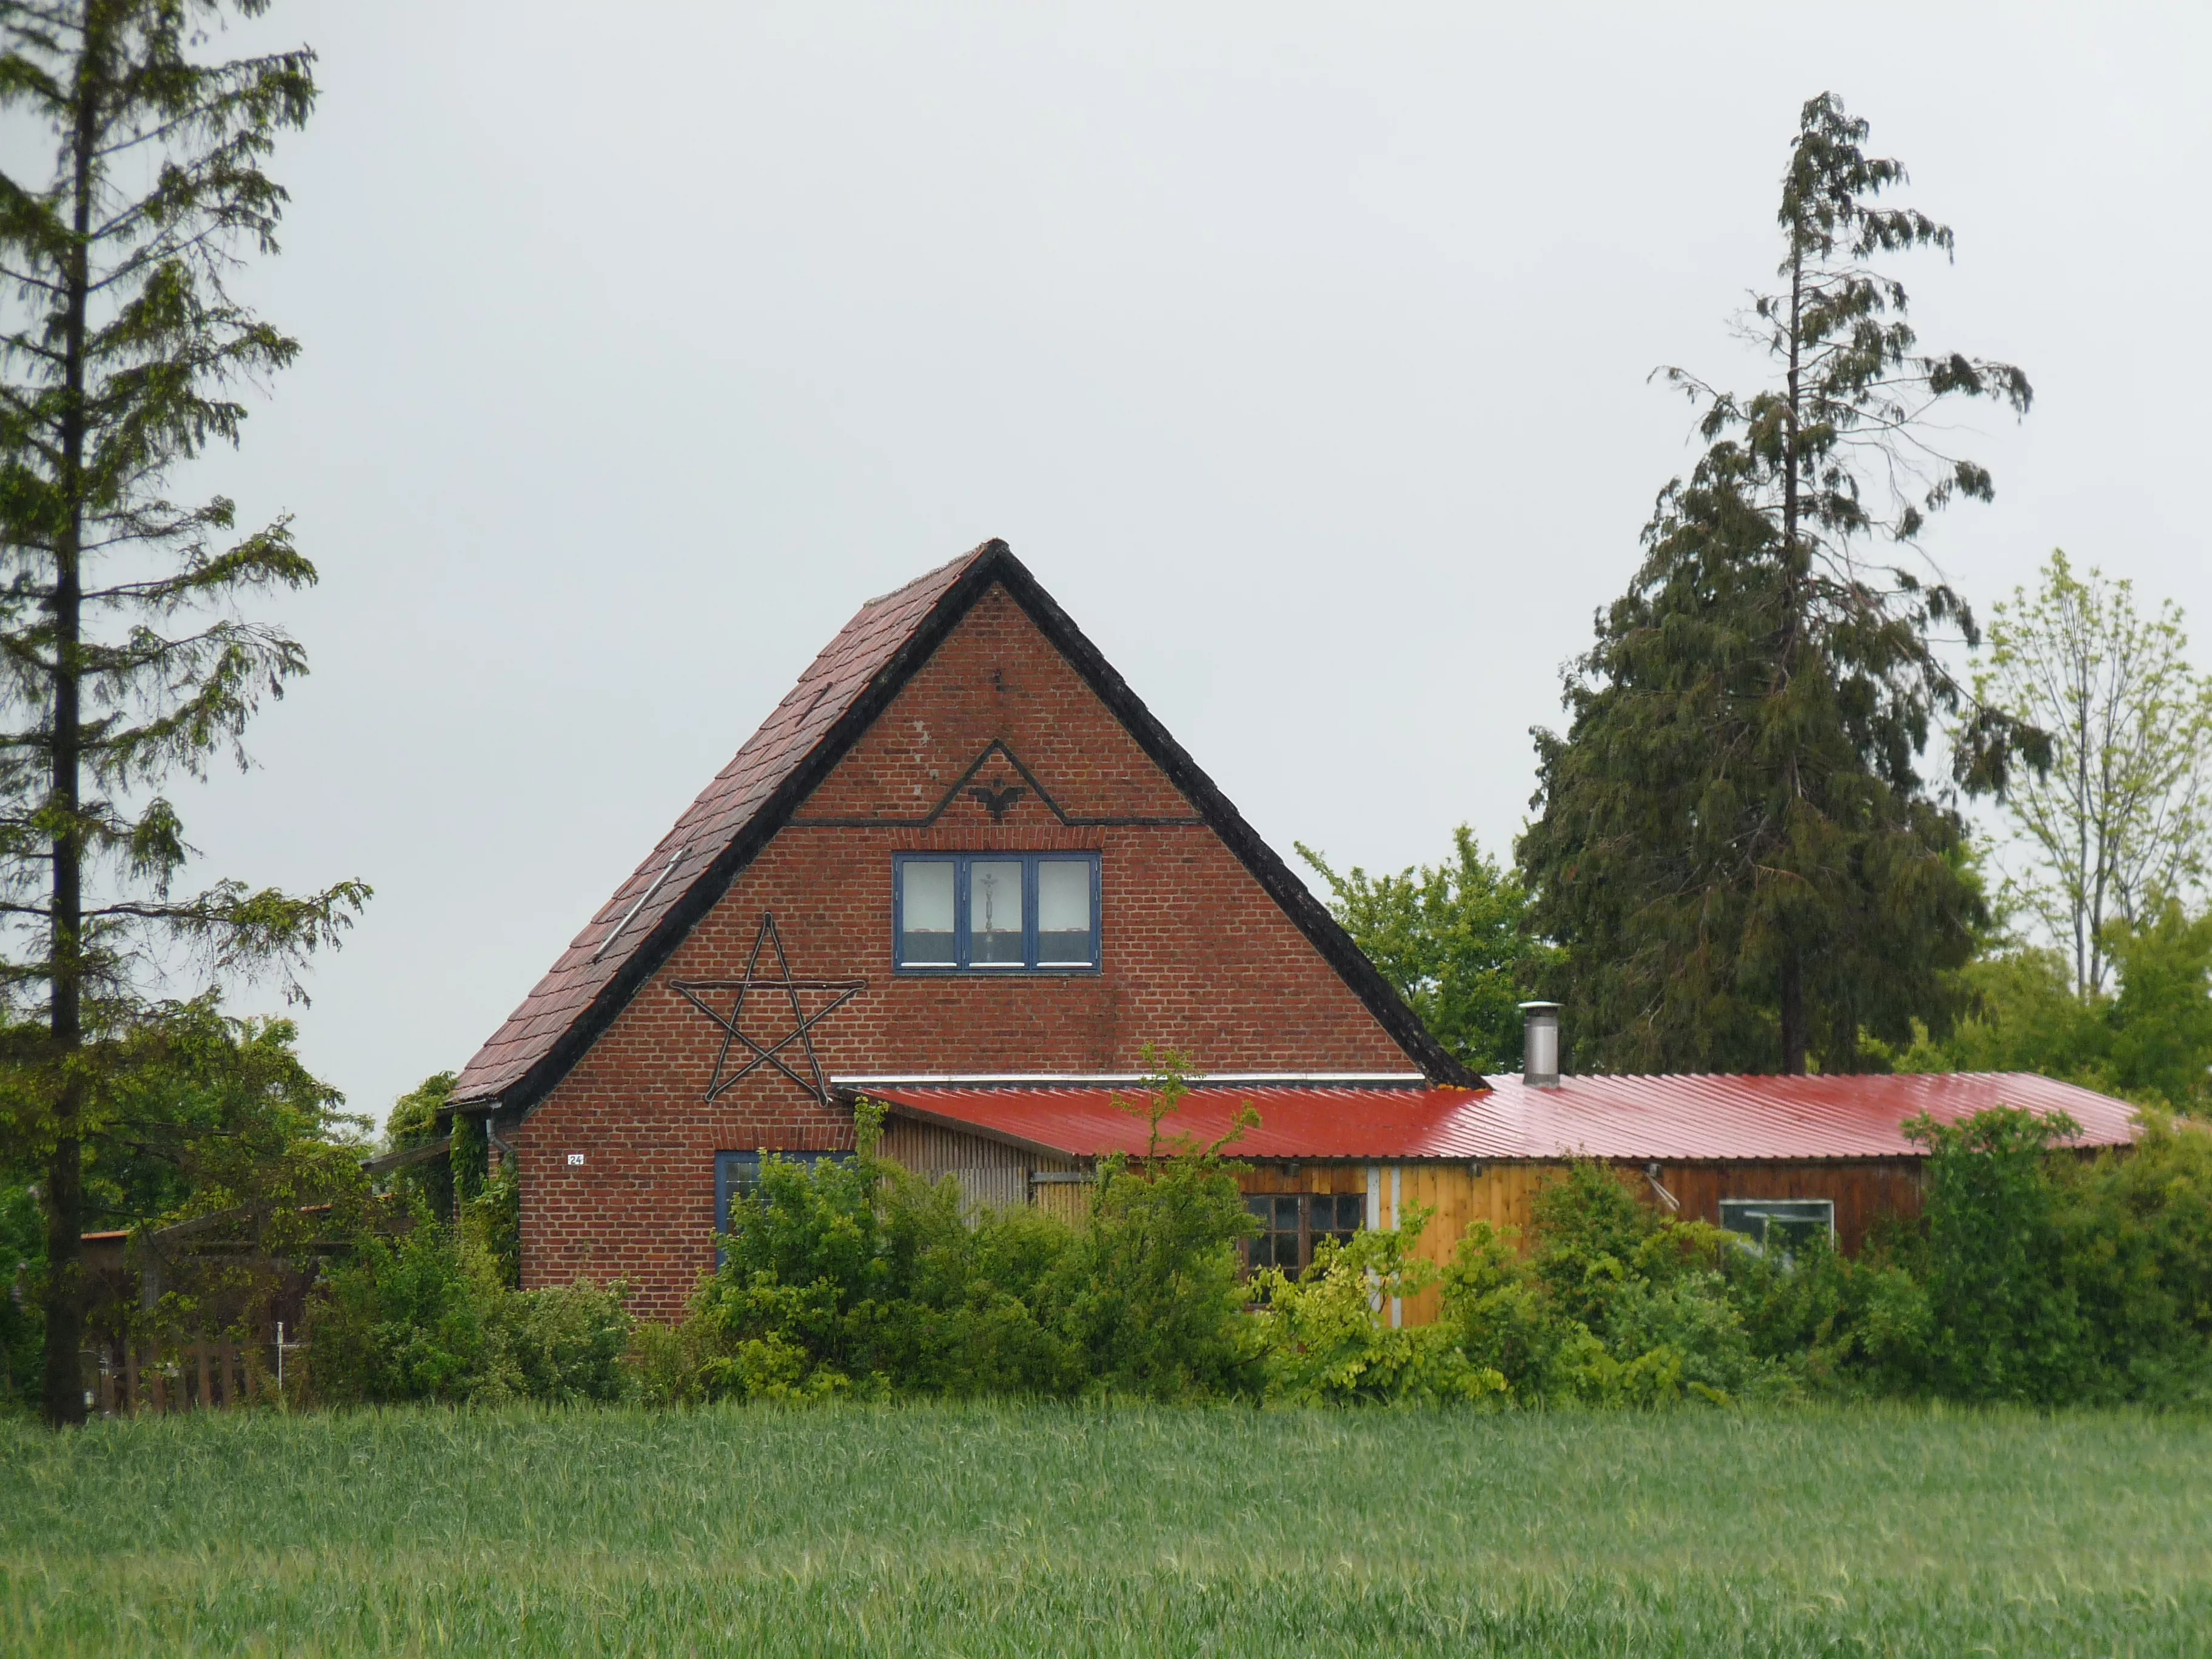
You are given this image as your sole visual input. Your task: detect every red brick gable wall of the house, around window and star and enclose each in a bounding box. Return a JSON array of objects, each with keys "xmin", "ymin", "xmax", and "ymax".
[{"xmin": 511, "ymin": 588, "xmax": 1413, "ymax": 1318}]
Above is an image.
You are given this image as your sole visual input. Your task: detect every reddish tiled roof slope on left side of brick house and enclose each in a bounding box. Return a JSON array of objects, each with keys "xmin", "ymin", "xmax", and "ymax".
[{"xmin": 454, "ymin": 553, "xmax": 1004, "ymax": 1104}]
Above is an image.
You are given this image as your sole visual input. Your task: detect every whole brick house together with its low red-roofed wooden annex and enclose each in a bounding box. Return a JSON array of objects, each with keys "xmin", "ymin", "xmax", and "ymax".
[{"xmin": 454, "ymin": 542, "xmax": 2133, "ymax": 1318}]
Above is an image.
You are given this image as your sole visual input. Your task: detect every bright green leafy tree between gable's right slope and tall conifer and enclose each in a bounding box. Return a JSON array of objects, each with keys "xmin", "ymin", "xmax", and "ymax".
[{"xmin": 1296, "ymin": 823, "xmax": 1553, "ymax": 1071}]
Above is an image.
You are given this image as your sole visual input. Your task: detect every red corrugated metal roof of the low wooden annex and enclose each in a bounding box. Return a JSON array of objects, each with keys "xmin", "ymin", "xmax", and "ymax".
[{"xmin": 867, "ymin": 1073, "xmax": 2134, "ymax": 1164}]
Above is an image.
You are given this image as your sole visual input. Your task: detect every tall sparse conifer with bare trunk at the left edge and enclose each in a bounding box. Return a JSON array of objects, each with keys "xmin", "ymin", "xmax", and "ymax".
[{"xmin": 0, "ymin": 0, "xmax": 367, "ymax": 1423}]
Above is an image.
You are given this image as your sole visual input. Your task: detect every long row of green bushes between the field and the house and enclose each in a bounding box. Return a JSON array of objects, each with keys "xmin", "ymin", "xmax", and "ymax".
[{"xmin": 310, "ymin": 1110, "xmax": 2212, "ymax": 1409}]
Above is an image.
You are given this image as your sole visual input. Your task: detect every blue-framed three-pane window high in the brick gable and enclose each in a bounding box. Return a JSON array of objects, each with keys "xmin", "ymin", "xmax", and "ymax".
[{"xmin": 891, "ymin": 851, "xmax": 1099, "ymax": 976}]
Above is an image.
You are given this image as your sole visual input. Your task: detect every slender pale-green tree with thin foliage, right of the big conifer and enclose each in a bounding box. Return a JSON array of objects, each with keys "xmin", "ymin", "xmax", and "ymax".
[{"xmin": 1976, "ymin": 551, "xmax": 2212, "ymax": 997}]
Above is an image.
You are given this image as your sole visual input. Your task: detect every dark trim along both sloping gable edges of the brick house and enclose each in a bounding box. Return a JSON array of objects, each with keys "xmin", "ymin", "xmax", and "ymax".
[{"xmin": 480, "ymin": 537, "xmax": 1489, "ymax": 1110}]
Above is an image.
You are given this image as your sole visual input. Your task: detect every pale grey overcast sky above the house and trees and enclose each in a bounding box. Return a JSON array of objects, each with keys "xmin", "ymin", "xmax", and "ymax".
[{"xmin": 156, "ymin": 0, "xmax": 2212, "ymax": 1115}]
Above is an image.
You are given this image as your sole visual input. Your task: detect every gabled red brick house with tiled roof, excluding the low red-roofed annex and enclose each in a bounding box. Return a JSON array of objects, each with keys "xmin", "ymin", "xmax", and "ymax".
[{"xmin": 454, "ymin": 542, "xmax": 1478, "ymax": 1316}]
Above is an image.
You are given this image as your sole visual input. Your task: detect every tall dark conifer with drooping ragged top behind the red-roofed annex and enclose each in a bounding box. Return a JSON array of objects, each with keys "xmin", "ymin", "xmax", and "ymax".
[{"xmin": 1518, "ymin": 95, "xmax": 2048, "ymax": 1073}]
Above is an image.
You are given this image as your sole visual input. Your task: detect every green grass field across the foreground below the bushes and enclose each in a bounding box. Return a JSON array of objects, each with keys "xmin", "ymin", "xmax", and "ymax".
[{"xmin": 0, "ymin": 1407, "xmax": 2212, "ymax": 1659}]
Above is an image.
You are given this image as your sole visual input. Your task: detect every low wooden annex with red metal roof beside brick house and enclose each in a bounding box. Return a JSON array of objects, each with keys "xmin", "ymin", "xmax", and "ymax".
[{"xmin": 839, "ymin": 1073, "xmax": 2134, "ymax": 1323}]
